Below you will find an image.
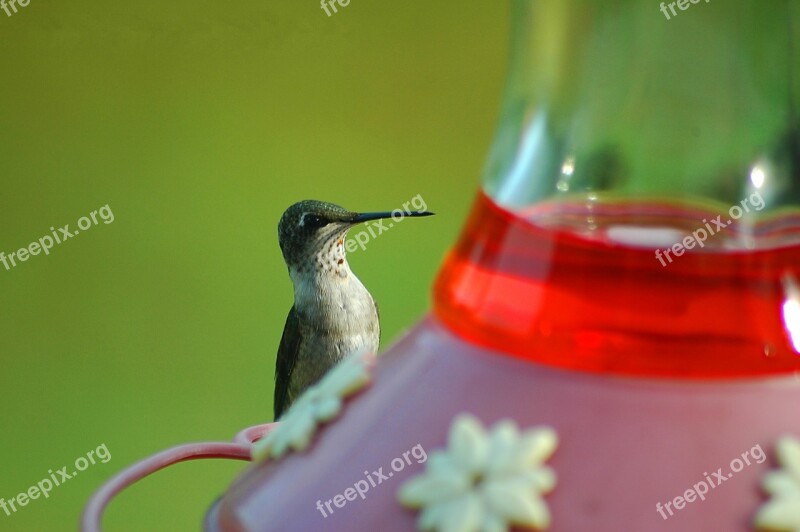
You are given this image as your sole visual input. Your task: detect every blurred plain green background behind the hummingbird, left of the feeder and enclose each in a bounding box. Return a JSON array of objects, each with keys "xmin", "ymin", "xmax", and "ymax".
[{"xmin": 0, "ymin": 0, "xmax": 508, "ymax": 531}]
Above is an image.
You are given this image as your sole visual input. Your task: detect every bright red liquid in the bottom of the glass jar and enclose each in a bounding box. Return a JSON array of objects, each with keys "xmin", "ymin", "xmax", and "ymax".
[{"xmin": 434, "ymin": 192, "xmax": 800, "ymax": 378}]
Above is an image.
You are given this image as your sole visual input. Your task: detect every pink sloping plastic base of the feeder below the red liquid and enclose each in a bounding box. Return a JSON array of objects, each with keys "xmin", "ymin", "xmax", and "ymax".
[{"xmin": 211, "ymin": 317, "xmax": 800, "ymax": 532}]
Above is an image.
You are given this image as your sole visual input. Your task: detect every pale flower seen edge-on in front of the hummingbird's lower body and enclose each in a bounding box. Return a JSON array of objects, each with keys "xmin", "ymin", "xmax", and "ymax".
[{"xmin": 251, "ymin": 352, "xmax": 375, "ymax": 462}]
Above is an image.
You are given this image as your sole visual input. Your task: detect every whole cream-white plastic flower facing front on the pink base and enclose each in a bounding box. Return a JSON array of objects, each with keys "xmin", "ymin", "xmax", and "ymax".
[{"xmin": 398, "ymin": 414, "xmax": 558, "ymax": 532}]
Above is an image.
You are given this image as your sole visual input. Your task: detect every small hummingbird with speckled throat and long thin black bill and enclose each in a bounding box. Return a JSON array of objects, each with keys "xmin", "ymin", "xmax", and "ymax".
[{"xmin": 273, "ymin": 200, "xmax": 434, "ymax": 420}]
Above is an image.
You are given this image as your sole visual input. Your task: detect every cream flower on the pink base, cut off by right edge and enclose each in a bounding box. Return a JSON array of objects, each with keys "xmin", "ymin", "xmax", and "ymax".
[{"xmin": 755, "ymin": 436, "xmax": 800, "ymax": 532}]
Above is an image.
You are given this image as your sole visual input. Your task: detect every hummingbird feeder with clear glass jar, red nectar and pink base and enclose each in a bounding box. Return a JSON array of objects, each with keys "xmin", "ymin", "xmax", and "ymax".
[{"xmin": 206, "ymin": 0, "xmax": 800, "ymax": 532}]
